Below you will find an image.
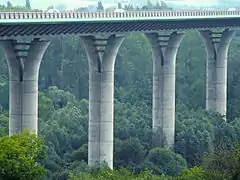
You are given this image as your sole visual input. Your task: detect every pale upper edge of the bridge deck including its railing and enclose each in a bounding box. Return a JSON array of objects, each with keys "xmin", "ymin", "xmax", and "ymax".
[{"xmin": 0, "ymin": 11, "xmax": 240, "ymax": 24}]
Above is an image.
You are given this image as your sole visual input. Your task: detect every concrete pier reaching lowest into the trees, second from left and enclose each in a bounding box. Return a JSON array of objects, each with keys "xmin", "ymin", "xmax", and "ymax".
[{"xmin": 82, "ymin": 36, "xmax": 124, "ymax": 168}]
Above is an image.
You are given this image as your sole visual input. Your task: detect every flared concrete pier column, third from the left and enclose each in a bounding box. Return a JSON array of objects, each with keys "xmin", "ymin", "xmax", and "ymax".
[{"xmin": 146, "ymin": 32, "xmax": 183, "ymax": 148}]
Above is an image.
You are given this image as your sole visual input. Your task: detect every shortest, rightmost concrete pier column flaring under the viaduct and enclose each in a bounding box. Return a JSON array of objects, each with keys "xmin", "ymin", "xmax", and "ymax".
[{"xmin": 200, "ymin": 30, "xmax": 235, "ymax": 118}]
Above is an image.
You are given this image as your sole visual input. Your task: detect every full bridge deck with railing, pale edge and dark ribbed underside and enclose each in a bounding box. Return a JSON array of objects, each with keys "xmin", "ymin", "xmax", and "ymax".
[{"xmin": 0, "ymin": 11, "xmax": 240, "ymax": 38}]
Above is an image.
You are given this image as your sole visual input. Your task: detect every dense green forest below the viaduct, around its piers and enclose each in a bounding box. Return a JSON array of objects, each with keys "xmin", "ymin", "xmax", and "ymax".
[{"xmin": 0, "ymin": 1, "xmax": 240, "ymax": 180}]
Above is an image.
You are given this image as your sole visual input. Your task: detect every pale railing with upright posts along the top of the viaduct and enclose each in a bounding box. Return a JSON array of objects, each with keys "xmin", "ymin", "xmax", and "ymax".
[{"xmin": 0, "ymin": 11, "xmax": 240, "ymax": 19}]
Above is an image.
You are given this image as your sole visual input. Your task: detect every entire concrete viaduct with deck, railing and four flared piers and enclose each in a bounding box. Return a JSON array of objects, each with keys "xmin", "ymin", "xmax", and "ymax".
[{"xmin": 0, "ymin": 11, "xmax": 240, "ymax": 168}]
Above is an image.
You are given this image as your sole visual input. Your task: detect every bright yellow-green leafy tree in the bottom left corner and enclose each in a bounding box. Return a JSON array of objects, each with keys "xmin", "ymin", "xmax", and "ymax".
[{"xmin": 0, "ymin": 132, "xmax": 46, "ymax": 180}]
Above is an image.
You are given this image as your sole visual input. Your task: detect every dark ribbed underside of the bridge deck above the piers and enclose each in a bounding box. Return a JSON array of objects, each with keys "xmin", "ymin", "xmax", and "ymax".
[{"xmin": 0, "ymin": 19, "xmax": 240, "ymax": 38}]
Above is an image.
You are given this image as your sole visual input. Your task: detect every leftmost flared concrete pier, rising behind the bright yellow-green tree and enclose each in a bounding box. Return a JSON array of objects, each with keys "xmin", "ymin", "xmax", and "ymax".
[{"xmin": 0, "ymin": 39, "xmax": 50, "ymax": 136}]
